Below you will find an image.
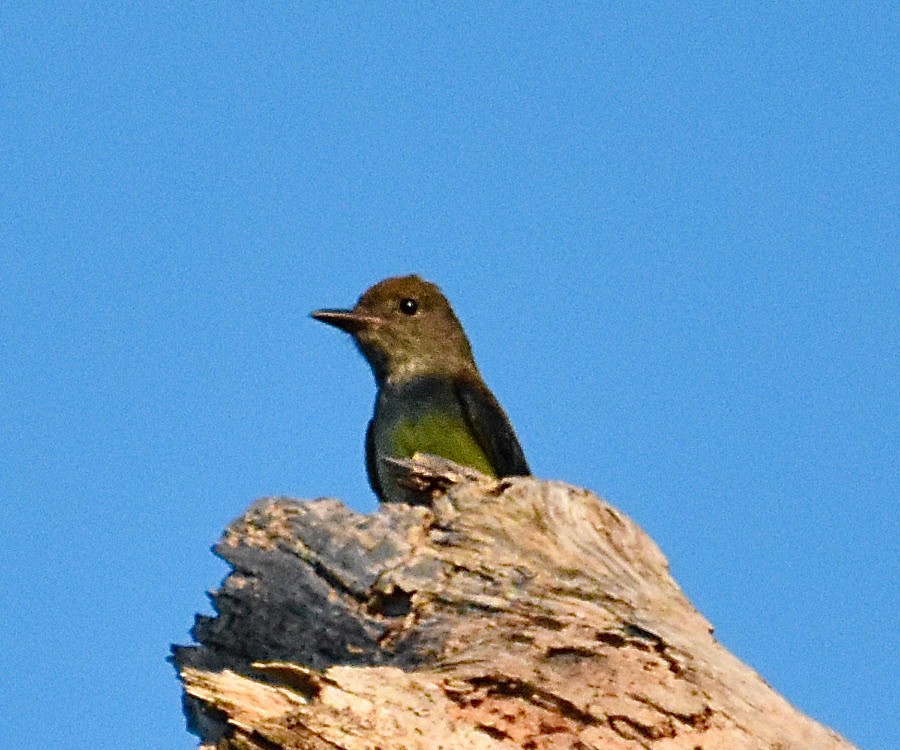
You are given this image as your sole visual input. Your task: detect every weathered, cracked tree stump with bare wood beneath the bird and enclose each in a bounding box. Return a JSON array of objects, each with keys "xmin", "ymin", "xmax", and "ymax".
[{"xmin": 174, "ymin": 457, "xmax": 852, "ymax": 750}]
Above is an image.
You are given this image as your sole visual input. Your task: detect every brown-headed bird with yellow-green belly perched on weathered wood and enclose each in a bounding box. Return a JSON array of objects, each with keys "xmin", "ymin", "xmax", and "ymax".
[{"xmin": 311, "ymin": 275, "xmax": 531, "ymax": 502}]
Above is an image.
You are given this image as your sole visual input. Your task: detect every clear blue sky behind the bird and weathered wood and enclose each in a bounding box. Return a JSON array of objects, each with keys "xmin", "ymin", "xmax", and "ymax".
[{"xmin": 0, "ymin": 2, "xmax": 900, "ymax": 749}]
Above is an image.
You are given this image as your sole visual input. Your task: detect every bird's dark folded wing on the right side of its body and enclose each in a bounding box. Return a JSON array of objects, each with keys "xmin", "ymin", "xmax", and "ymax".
[{"xmin": 454, "ymin": 380, "xmax": 531, "ymax": 477}]
